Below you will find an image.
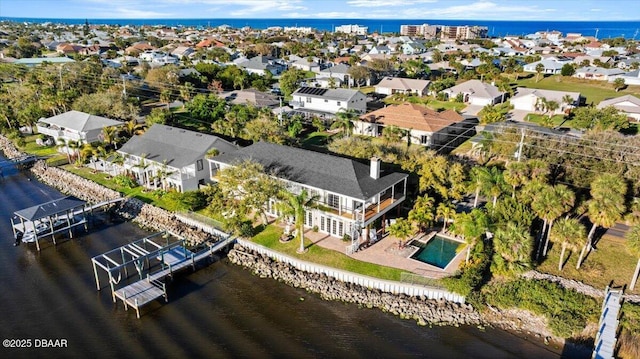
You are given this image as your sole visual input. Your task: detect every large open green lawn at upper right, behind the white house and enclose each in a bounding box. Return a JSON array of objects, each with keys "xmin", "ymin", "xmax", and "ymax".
[{"xmin": 517, "ymin": 75, "xmax": 640, "ymax": 105}]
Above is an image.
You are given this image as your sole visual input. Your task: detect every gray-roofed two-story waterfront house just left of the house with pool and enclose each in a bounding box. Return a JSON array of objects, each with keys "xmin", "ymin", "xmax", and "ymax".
[{"xmin": 118, "ymin": 124, "xmax": 237, "ymax": 192}]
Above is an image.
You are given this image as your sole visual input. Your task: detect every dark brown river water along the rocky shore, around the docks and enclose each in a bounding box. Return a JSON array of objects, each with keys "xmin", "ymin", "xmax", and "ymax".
[{"xmin": 0, "ymin": 158, "xmax": 562, "ymax": 358}]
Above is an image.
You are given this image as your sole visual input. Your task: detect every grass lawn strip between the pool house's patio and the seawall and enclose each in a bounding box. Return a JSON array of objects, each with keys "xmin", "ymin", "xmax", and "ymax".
[{"xmin": 252, "ymin": 225, "xmax": 404, "ymax": 281}]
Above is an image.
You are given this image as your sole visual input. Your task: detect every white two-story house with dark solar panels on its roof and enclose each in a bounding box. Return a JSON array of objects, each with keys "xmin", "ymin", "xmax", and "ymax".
[{"xmin": 290, "ymin": 87, "xmax": 367, "ymax": 115}]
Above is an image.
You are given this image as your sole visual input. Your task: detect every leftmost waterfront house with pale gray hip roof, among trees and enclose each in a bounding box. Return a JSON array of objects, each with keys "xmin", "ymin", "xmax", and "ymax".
[{"xmin": 36, "ymin": 110, "xmax": 124, "ymax": 152}]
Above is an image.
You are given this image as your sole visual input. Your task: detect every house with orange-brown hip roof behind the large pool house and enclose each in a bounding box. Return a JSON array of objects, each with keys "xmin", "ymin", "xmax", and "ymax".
[{"xmin": 354, "ymin": 103, "xmax": 478, "ymax": 150}]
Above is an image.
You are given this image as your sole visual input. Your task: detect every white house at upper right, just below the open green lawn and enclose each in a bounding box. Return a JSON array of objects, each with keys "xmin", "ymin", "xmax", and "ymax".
[{"xmin": 509, "ymin": 87, "xmax": 583, "ymax": 114}]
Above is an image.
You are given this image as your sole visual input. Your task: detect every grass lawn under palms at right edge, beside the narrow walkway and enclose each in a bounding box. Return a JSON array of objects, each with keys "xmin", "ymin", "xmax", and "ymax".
[{"xmin": 538, "ymin": 236, "xmax": 640, "ymax": 294}]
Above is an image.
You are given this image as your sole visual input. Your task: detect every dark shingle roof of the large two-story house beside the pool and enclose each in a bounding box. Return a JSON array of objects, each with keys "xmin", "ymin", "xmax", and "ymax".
[{"xmin": 212, "ymin": 142, "xmax": 407, "ymax": 200}]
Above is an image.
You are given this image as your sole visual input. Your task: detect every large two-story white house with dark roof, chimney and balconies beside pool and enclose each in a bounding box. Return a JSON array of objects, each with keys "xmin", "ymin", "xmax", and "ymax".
[{"xmin": 209, "ymin": 142, "xmax": 408, "ymax": 239}]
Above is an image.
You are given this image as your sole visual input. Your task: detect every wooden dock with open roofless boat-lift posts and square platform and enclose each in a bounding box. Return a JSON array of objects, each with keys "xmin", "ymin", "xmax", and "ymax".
[{"xmin": 99, "ymin": 236, "xmax": 235, "ymax": 318}]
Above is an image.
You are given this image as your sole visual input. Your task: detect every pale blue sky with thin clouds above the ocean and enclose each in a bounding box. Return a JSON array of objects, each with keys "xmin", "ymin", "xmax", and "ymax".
[{"xmin": 0, "ymin": 0, "xmax": 640, "ymax": 21}]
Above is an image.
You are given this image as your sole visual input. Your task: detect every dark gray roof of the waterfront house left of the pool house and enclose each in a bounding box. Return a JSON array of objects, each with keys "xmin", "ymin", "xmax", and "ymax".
[{"xmin": 118, "ymin": 124, "xmax": 237, "ymax": 168}]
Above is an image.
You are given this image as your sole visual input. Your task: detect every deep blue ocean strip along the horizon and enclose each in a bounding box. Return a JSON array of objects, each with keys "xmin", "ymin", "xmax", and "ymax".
[{"xmin": 0, "ymin": 17, "xmax": 640, "ymax": 39}]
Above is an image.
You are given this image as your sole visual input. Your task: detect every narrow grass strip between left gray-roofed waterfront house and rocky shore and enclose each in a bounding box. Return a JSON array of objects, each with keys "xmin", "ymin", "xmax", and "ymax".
[{"xmin": 62, "ymin": 165, "xmax": 186, "ymax": 211}]
